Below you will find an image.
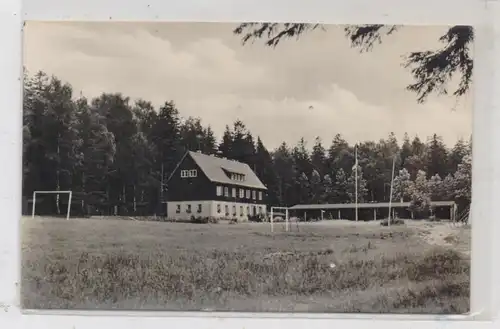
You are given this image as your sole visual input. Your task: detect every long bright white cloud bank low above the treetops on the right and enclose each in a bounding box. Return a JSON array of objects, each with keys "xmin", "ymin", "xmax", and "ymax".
[{"xmin": 179, "ymin": 85, "xmax": 470, "ymax": 148}]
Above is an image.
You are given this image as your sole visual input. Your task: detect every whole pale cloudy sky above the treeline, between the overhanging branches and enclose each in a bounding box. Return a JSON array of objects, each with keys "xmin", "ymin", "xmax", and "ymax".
[{"xmin": 24, "ymin": 22, "xmax": 472, "ymax": 149}]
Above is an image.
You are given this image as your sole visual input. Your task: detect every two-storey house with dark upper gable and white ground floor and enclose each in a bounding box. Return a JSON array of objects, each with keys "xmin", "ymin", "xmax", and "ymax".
[{"xmin": 166, "ymin": 151, "xmax": 267, "ymax": 220}]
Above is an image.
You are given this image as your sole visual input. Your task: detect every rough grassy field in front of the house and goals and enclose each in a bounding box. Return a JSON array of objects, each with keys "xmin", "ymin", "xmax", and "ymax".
[{"xmin": 21, "ymin": 218, "xmax": 470, "ymax": 313}]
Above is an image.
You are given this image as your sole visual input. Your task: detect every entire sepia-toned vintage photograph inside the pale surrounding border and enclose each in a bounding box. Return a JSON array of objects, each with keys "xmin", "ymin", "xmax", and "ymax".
[{"xmin": 21, "ymin": 21, "xmax": 474, "ymax": 314}]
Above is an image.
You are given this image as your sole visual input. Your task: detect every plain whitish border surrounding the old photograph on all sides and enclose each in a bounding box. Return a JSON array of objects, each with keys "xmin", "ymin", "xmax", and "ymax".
[{"xmin": 0, "ymin": 0, "xmax": 500, "ymax": 329}]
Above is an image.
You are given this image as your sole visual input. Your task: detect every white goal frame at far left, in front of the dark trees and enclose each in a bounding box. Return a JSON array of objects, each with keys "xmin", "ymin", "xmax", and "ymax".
[{"xmin": 31, "ymin": 191, "xmax": 73, "ymax": 220}]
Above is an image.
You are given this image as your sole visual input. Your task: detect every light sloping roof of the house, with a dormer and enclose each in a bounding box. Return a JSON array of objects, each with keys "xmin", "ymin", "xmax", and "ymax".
[{"xmin": 184, "ymin": 151, "xmax": 267, "ymax": 190}]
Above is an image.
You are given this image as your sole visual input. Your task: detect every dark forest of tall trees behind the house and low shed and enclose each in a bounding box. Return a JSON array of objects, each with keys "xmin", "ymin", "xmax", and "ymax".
[{"xmin": 23, "ymin": 72, "xmax": 471, "ymax": 215}]
